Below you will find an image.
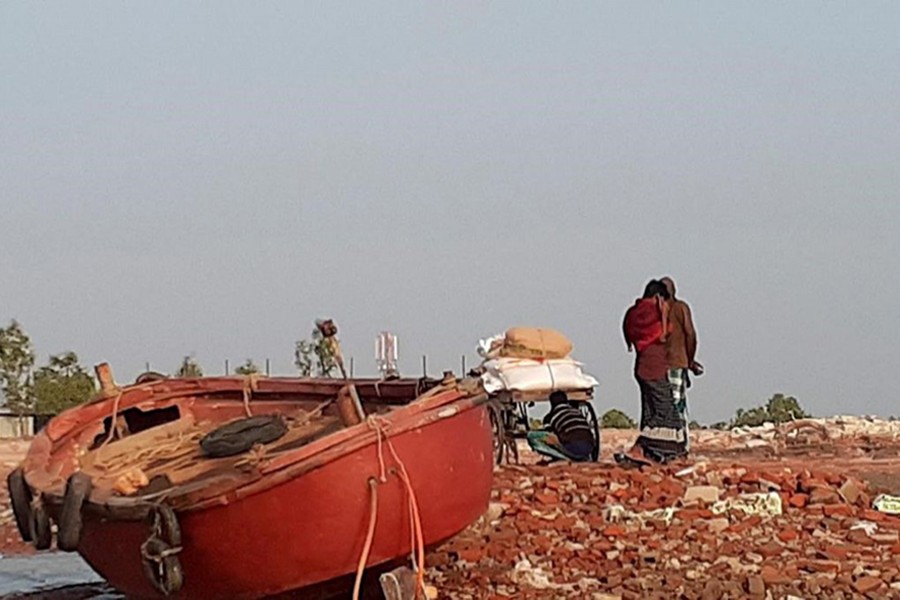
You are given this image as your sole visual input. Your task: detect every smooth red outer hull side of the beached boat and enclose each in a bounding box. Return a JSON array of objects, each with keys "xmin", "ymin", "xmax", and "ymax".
[{"xmin": 78, "ymin": 403, "xmax": 493, "ymax": 598}]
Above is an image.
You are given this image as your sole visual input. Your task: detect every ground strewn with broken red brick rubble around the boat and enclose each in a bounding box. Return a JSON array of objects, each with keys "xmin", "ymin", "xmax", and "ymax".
[{"xmin": 0, "ymin": 417, "xmax": 900, "ymax": 600}]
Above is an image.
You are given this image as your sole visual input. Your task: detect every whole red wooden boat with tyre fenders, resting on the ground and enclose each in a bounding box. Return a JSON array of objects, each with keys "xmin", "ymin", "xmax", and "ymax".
[{"xmin": 9, "ymin": 371, "xmax": 492, "ymax": 598}]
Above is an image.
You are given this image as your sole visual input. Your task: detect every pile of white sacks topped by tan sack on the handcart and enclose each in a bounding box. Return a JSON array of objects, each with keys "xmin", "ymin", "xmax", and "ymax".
[{"xmin": 478, "ymin": 327, "xmax": 597, "ymax": 394}]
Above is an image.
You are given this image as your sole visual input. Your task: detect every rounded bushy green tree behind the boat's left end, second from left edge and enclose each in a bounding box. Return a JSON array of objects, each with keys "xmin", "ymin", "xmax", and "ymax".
[{"xmin": 34, "ymin": 352, "xmax": 96, "ymax": 416}]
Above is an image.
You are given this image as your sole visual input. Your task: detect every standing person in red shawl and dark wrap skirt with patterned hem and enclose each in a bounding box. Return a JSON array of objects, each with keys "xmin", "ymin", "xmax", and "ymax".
[{"xmin": 616, "ymin": 279, "xmax": 687, "ymax": 464}]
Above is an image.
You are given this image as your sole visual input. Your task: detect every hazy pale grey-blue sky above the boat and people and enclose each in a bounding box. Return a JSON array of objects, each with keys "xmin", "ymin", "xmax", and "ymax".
[{"xmin": 0, "ymin": 2, "xmax": 900, "ymax": 422}]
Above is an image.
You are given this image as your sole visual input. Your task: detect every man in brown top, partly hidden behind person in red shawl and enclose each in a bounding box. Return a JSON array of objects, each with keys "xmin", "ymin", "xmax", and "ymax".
[{"xmin": 660, "ymin": 277, "xmax": 703, "ymax": 446}]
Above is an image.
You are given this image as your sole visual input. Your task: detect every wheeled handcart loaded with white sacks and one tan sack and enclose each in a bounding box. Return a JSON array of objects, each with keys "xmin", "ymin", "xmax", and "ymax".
[{"xmin": 478, "ymin": 327, "xmax": 600, "ymax": 464}]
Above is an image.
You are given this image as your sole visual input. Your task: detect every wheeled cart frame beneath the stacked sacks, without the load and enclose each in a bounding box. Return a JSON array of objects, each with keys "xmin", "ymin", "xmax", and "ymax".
[{"xmin": 491, "ymin": 388, "xmax": 600, "ymax": 465}]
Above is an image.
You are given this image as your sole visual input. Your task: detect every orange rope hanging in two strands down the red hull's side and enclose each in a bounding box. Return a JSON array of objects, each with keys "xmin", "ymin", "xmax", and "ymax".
[{"xmin": 353, "ymin": 415, "xmax": 425, "ymax": 600}]
